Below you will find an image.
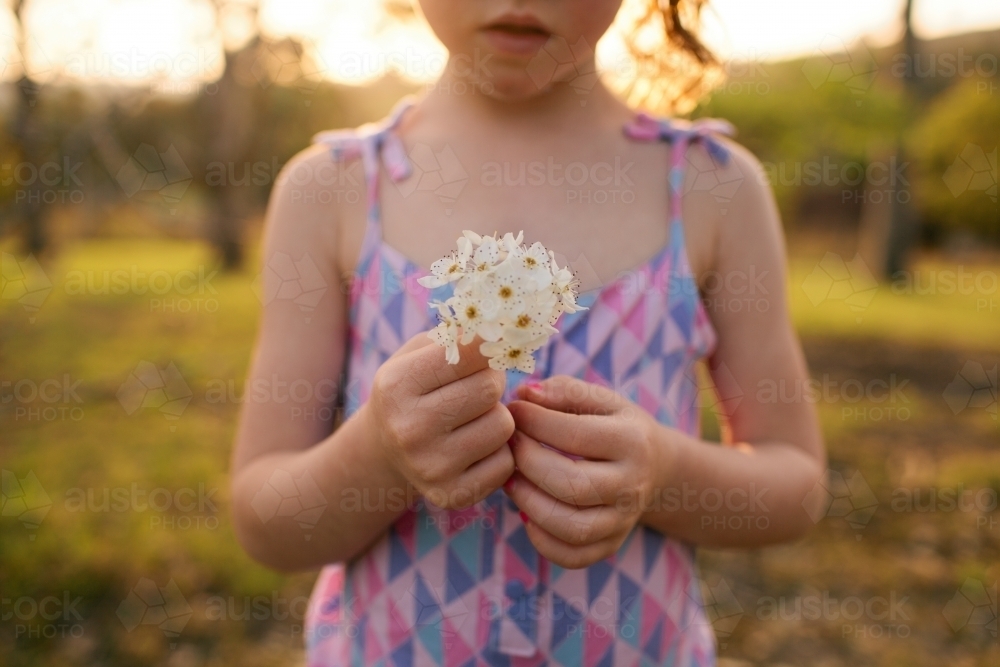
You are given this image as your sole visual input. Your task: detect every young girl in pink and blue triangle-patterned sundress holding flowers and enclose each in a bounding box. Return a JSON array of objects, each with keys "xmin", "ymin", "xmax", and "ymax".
[{"xmin": 232, "ymin": 0, "xmax": 824, "ymax": 667}]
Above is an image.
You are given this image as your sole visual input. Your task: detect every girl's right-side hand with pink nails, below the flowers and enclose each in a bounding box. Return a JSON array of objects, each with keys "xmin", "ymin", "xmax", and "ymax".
[{"xmin": 504, "ymin": 375, "xmax": 669, "ymax": 568}]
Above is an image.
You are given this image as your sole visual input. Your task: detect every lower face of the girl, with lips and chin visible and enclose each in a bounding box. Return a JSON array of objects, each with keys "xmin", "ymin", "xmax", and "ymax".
[{"xmin": 419, "ymin": 0, "xmax": 622, "ymax": 101}]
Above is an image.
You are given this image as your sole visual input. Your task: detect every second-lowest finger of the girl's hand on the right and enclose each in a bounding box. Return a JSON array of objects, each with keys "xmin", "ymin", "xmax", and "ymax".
[{"xmin": 505, "ymin": 473, "xmax": 624, "ymax": 546}]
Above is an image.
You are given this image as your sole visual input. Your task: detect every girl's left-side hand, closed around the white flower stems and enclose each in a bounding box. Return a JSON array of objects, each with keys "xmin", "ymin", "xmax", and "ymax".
[{"xmin": 362, "ymin": 332, "xmax": 514, "ymax": 509}]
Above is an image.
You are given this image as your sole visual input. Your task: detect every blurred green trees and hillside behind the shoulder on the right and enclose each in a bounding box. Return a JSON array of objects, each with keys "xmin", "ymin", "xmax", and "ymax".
[{"xmin": 695, "ymin": 33, "xmax": 1000, "ymax": 239}]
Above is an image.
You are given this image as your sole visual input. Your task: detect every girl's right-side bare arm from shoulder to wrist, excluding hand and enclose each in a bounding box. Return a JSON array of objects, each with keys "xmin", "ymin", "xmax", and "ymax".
[{"xmin": 642, "ymin": 143, "xmax": 825, "ymax": 546}]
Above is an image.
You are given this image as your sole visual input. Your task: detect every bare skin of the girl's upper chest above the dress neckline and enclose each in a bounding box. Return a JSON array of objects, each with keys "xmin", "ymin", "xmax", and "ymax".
[{"xmin": 340, "ymin": 137, "xmax": 711, "ymax": 290}]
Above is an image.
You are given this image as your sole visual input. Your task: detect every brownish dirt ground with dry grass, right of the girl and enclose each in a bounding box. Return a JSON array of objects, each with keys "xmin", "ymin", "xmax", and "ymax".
[{"xmin": 700, "ymin": 337, "xmax": 1000, "ymax": 667}]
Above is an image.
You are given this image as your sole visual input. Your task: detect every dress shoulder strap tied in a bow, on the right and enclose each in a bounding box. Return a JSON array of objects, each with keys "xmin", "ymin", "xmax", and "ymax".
[{"xmin": 625, "ymin": 113, "xmax": 736, "ymax": 221}]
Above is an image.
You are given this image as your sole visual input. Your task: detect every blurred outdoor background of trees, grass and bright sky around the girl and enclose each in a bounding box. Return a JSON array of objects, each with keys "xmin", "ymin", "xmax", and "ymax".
[{"xmin": 0, "ymin": 0, "xmax": 1000, "ymax": 667}]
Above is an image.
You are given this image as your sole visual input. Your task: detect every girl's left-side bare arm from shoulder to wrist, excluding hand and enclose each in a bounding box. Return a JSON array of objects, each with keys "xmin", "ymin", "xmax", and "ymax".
[{"xmin": 232, "ymin": 148, "xmax": 405, "ymax": 569}]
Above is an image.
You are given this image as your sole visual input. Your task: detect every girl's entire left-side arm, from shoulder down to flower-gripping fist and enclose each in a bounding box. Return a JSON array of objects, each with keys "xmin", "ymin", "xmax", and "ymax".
[{"xmin": 231, "ymin": 149, "xmax": 514, "ymax": 570}]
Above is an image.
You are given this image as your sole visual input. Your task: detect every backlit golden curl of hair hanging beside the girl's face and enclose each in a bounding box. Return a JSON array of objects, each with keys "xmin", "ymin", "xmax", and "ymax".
[{"xmin": 619, "ymin": 0, "xmax": 723, "ymax": 114}]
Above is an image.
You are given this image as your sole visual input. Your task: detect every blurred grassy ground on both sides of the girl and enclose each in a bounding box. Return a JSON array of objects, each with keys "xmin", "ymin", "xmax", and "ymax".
[{"xmin": 0, "ymin": 240, "xmax": 1000, "ymax": 666}]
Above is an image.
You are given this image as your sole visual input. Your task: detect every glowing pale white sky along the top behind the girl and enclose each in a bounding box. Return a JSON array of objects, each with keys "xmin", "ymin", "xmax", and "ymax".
[{"xmin": 0, "ymin": 0, "xmax": 1000, "ymax": 86}]
